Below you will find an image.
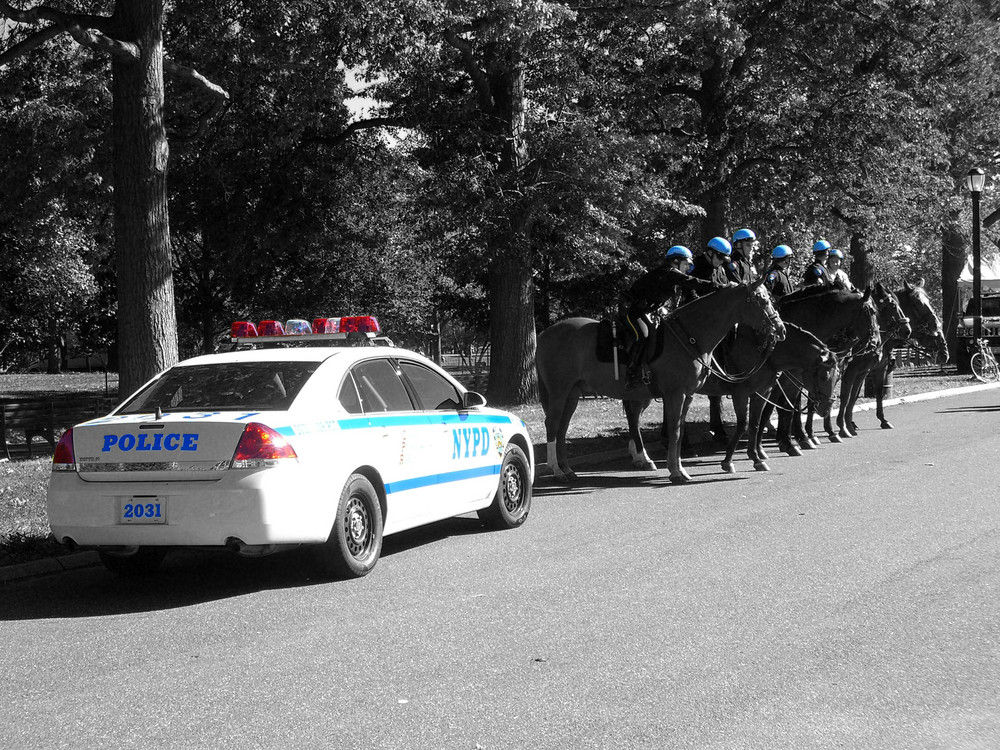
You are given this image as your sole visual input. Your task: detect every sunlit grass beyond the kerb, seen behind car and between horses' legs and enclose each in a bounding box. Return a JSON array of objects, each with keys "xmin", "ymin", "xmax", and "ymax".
[{"xmin": 0, "ymin": 370, "xmax": 969, "ymax": 566}]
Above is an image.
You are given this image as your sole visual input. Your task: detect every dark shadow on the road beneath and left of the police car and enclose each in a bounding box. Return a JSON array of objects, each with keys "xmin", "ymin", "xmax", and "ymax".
[{"xmin": 0, "ymin": 514, "xmax": 494, "ymax": 622}]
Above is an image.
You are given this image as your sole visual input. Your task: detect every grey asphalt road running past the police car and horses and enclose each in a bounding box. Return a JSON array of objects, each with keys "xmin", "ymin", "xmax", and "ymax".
[{"xmin": 0, "ymin": 391, "xmax": 1000, "ymax": 750}]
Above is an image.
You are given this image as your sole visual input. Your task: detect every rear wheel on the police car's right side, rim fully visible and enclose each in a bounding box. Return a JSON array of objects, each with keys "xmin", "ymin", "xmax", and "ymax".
[{"xmin": 317, "ymin": 474, "xmax": 382, "ymax": 578}]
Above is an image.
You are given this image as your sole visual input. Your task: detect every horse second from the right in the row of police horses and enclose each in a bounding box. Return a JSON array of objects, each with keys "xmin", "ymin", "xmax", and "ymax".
[{"xmin": 824, "ymin": 282, "xmax": 911, "ymax": 438}]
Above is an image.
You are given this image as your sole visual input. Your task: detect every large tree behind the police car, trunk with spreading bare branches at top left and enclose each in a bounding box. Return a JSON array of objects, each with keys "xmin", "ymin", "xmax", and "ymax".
[{"xmin": 0, "ymin": 0, "xmax": 228, "ymax": 393}]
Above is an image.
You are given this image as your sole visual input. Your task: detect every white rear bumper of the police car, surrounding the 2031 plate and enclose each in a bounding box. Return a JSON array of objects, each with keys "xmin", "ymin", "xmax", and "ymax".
[{"xmin": 48, "ymin": 467, "xmax": 339, "ymax": 547}]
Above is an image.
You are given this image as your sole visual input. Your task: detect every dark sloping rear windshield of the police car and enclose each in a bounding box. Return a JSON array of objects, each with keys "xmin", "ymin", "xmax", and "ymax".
[{"xmin": 118, "ymin": 362, "xmax": 320, "ymax": 414}]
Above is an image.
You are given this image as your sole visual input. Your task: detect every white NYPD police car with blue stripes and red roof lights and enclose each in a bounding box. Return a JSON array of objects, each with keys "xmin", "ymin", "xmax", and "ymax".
[{"xmin": 48, "ymin": 316, "xmax": 534, "ymax": 577}]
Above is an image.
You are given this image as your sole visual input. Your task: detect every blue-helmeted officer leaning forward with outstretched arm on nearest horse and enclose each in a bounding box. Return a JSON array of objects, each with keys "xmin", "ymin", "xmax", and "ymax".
[{"xmin": 620, "ymin": 245, "xmax": 725, "ymax": 398}]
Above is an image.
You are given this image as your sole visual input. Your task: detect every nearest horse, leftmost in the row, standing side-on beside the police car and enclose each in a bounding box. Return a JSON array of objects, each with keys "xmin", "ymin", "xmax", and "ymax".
[{"xmin": 535, "ymin": 281, "xmax": 785, "ymax": 482}]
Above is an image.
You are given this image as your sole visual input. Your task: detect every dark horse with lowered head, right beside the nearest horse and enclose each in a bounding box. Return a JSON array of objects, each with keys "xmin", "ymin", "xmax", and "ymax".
[{"xmin": 698, "ymin": 323, "xmax": 837, "ymax": 473}]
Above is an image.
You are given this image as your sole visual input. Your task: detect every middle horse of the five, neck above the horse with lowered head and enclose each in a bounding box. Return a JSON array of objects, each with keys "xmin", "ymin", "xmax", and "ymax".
[{"xmin": 762, "ymin": 287, "xmax": 878, "ymax": 456}]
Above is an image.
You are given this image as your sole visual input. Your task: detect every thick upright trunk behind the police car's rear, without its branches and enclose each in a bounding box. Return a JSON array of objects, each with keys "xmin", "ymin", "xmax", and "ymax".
[{"xmin": 112, "ymin": 0, "xmax": 177, "ymax": 396}]
